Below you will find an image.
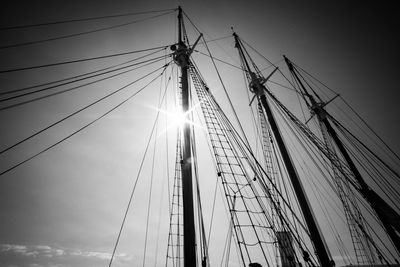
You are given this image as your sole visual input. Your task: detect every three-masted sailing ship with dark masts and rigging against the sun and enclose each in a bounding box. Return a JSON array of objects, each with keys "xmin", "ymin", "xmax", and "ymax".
[{"xmin": 1, "ymin": 4, "xmax": 400, "ymax": 267}]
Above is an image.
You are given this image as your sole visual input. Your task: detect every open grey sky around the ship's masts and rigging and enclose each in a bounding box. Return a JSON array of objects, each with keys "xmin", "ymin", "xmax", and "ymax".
[{"xmin": 0, "ymin": 0, "xmax": 400, "ymax": 267}]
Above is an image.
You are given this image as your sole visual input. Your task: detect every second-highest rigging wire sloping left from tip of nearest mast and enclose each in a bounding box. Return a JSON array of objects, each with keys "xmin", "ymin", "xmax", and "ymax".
[{"xmin": 0, "ymin": 11, "xmax": 173, "ymax": 50}]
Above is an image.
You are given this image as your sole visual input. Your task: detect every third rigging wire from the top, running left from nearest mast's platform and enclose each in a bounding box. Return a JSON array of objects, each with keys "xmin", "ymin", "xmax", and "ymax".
[{"xmin": 0, "ymin": 45, "xmax": 169, "ymax": 74}]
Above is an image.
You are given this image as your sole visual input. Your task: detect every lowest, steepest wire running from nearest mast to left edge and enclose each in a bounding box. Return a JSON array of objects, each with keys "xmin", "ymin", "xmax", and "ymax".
[{"xmin": 0, "ymin": 63, "xmax": 169, "ymax": 176}]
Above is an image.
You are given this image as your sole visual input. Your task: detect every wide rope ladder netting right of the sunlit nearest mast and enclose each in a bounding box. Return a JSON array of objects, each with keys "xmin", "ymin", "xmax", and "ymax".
[{"xmin": 190, "ymin": 67, "xmax": 284, "ymax": 263}]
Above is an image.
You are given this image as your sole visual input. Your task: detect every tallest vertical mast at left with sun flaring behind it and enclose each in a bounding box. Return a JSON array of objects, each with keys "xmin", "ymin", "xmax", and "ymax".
[{"xmin": 174, "ymin": 6, "xmax": 196, "ymax": 267}]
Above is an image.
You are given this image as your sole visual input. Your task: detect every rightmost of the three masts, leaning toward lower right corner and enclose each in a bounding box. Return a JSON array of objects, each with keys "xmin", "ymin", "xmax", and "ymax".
[{"xmin": 284, "ymin": 56, "xmax": 400, "ymax": 253}]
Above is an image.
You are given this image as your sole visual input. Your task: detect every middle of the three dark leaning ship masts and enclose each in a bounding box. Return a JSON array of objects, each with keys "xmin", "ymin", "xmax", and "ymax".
[{"xmin": 233, "ymin": 33, "xmax": 332, "ymax": 267}]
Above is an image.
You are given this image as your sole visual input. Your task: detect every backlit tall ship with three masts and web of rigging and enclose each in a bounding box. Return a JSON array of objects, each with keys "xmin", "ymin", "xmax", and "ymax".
[{"xmin": 0, "ymin": 4, "xmax": 400, "ymax": 267}]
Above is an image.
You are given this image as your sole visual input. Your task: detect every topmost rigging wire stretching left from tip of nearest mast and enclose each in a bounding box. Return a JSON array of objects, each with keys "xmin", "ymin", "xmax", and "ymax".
[{"xmin": 0, "ymin": 9, "xmax": 176, "ymax": 31}]
